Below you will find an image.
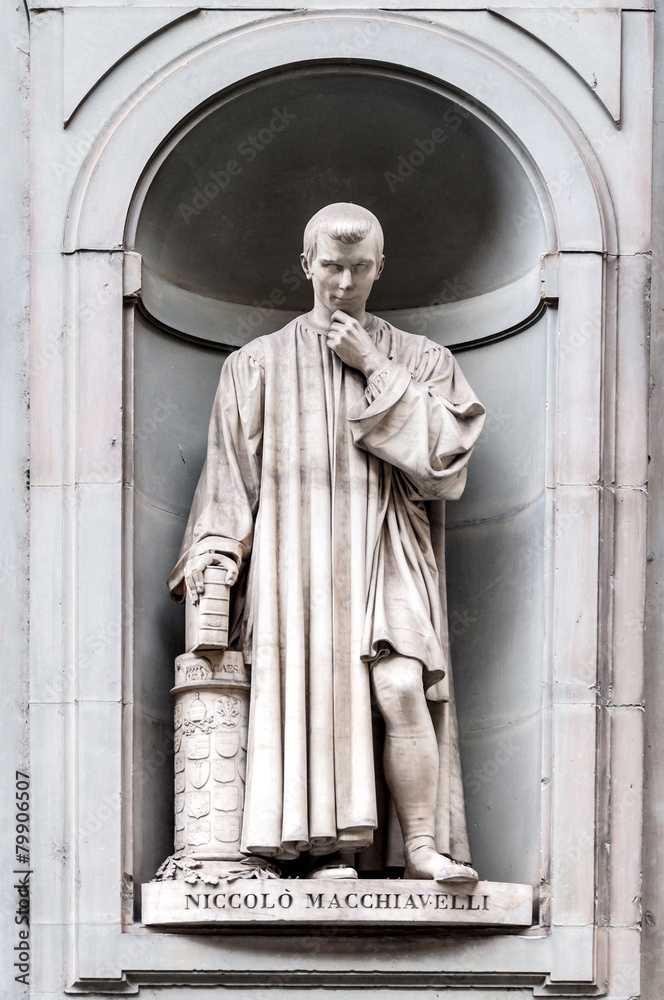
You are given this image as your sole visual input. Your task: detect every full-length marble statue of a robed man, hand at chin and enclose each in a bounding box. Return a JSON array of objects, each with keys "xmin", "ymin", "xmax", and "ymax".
[{"xmin": 169, "ymin": 203, "xmax": 484, "ymax": 881}]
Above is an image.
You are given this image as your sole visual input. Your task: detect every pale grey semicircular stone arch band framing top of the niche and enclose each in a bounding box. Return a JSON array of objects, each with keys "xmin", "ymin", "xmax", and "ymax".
[{"xmin": 64, "ymin": 11, "xmax": 617, "ymax": 253}]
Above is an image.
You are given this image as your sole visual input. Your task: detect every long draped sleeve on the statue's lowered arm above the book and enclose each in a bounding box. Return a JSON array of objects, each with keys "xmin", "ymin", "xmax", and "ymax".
[{"xmin": 168, "ymin": 341, "xmax": 264, "ymax": 601}]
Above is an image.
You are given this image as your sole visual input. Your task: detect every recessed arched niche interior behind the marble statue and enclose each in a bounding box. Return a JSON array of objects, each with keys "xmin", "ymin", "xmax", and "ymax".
[{"xmin": 129, "ymin": 58, "xmax": 552, "ymax": 896}]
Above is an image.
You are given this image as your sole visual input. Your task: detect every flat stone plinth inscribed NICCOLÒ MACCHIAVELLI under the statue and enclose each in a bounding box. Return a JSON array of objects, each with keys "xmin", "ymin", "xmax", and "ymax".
[{"xmin": 142, "ymin": 875, "xmax": 533, "ymax": 931}]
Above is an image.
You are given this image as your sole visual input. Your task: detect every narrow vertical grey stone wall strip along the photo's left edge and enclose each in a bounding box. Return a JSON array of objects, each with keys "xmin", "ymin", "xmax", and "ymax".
[{"xmin": 0, "ymin": 4, "xmax": 30, "ymax": 1000}]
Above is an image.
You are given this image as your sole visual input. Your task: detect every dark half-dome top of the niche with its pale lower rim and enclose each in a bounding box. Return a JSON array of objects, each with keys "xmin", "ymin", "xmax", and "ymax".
[{"xmin": 130, "ymin": 64, "xmax": 551, "ymax": 346}]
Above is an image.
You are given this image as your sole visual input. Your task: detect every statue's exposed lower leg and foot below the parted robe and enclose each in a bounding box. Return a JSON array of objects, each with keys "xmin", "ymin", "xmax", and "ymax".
[{"xmin": 372, "ymin": 655, "xmax": 477, "ymax": 881}]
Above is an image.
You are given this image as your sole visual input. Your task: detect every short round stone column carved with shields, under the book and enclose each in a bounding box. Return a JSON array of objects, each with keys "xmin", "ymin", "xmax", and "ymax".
[{"xmin": 171, "ymin": 650, "xmax": 249, "ymax": 861}]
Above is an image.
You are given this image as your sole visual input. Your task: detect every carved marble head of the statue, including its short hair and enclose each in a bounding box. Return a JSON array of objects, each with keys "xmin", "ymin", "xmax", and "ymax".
[{"xmin": 300, "ymin": 202, "xmax": 385, "ymax": 315}]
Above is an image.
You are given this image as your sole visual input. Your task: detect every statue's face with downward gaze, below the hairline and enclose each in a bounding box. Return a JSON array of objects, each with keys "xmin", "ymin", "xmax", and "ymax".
[{"xmin": 301, "ymin": 233, "xmax": 384, "ymax": 316}]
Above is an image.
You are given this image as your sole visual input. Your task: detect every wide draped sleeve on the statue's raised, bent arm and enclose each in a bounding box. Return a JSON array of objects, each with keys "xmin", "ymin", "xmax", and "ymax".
[{"xmin": 347, "ymin": 338, "xmax": 485, "ymax": 500}]
